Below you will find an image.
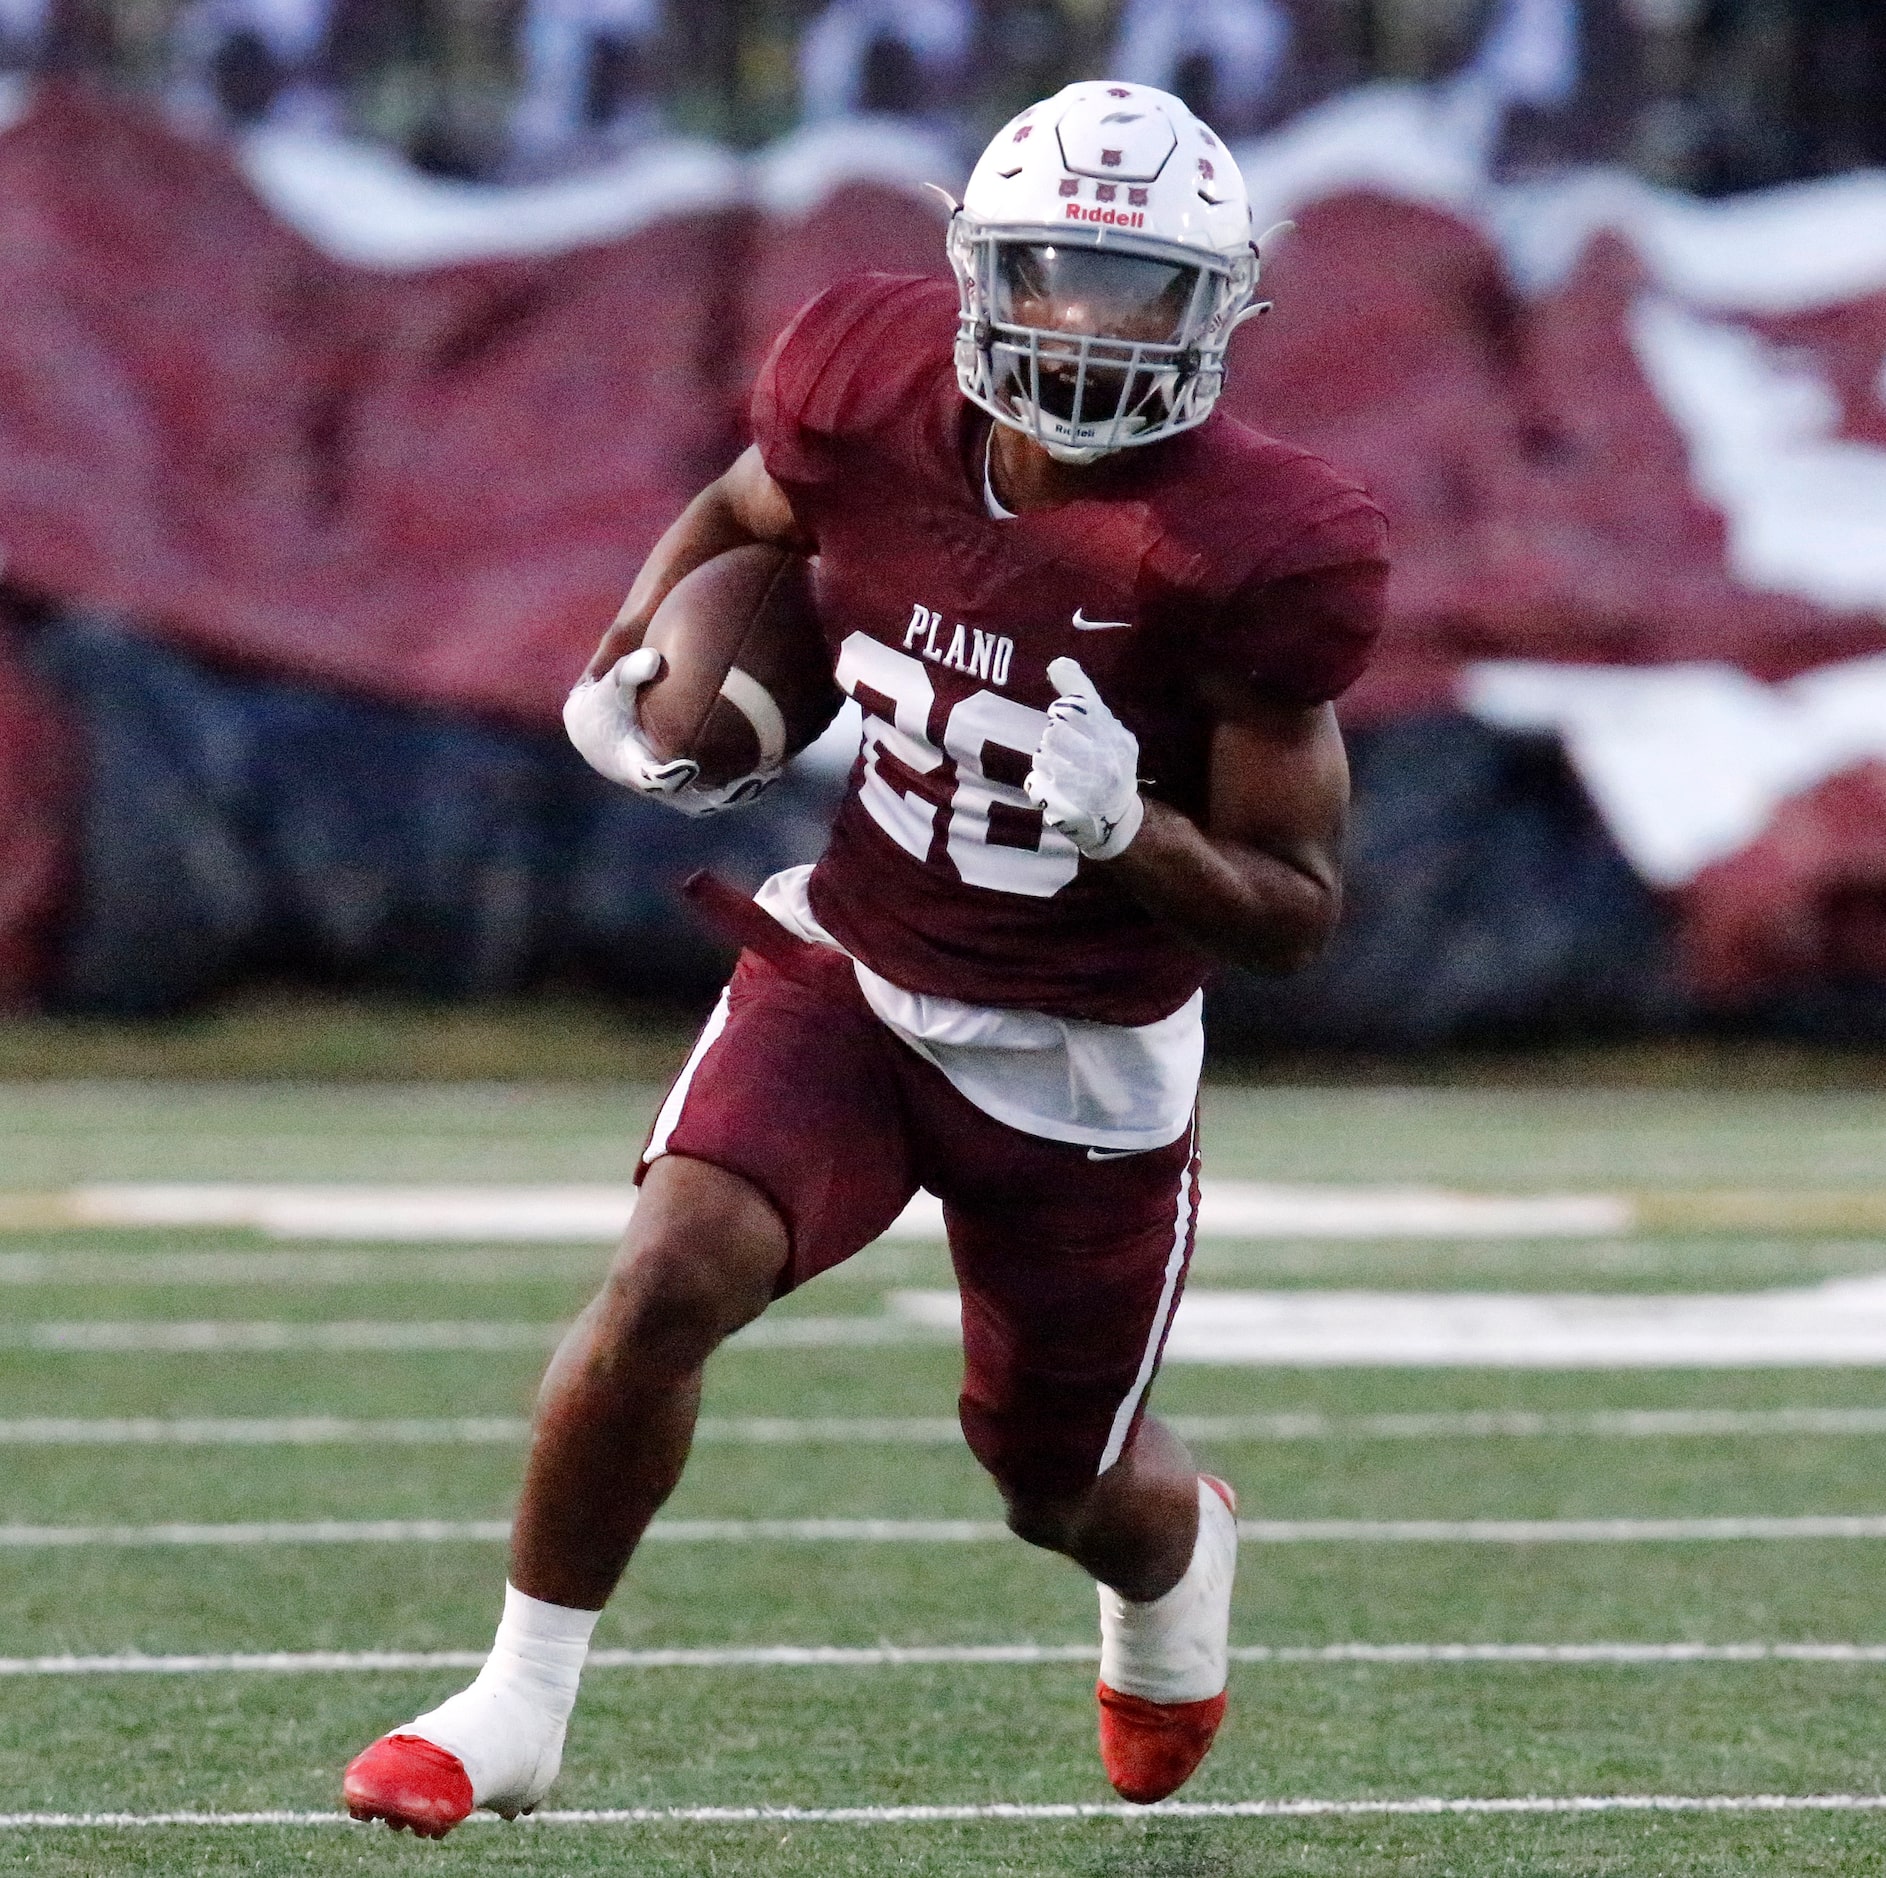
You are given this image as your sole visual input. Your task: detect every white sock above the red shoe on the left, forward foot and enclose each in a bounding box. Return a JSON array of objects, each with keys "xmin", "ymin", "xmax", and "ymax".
[{"xmin": 394, "ymin": 1584, "xmax": 602, "ymax": 1812}]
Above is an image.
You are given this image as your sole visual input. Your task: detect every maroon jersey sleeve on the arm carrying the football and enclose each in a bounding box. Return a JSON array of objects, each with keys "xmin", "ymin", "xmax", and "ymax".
[{"xmin": 751, "ymin": 273, "xmax": 954, "ymax": 501}]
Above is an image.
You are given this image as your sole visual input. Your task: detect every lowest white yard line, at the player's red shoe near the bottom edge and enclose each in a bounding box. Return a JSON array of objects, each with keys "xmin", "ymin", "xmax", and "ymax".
[{"xmin": 0, "ymin": 1793, "xmax": 1886, "ymax": 1833}]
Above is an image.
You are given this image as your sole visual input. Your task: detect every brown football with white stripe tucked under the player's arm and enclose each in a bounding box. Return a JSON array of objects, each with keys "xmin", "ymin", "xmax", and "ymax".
[{"xmin": 636, "ymin": 547, "xmax": 843, "ymax": 786}]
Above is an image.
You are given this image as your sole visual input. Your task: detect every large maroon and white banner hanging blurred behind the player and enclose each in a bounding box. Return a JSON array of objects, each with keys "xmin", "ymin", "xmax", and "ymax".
[{"xmin": 0, "ymin": 91, "xmax": 1886, "ymax": 988}]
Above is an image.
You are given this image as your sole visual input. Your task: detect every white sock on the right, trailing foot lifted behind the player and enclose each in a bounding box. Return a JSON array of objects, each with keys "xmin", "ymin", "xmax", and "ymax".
[{"xmin": 1100, "ymin": 1480, "xmax": 1237, "ymax": 1703}]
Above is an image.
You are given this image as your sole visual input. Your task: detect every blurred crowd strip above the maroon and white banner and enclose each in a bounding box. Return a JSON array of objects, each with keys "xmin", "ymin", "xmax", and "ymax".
[{"xmin": 0, "ymin": 0, "xmax": 1886, "ymax": 194}]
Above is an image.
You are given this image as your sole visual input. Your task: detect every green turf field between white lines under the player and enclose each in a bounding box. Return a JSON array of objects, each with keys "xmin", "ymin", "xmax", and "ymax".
[{"xmin": 0, "ymin": 1082, "xmax": 1886, "ymax": 1878}]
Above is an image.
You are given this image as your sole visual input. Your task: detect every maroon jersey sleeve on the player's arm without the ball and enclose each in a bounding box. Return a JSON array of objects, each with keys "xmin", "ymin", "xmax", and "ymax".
[{"xmin": 1205, "ymin": 496, "xmax": 1388, "ymax": 707}]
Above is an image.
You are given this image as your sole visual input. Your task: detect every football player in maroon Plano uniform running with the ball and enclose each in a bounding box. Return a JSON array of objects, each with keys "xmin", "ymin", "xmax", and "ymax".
[{"xmin": 345, "ymin": 83, "xmax": 1386, "ymax": 1835}]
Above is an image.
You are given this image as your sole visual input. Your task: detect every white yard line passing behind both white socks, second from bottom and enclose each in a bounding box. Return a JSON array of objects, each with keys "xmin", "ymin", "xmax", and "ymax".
[{"xmin": 0, "ymin": 1642, "xmax": 1886, "ymax": 1676}]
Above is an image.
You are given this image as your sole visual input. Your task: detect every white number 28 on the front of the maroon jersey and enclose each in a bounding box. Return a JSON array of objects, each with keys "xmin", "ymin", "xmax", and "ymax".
[{"xmin": 837, "ymin": 632, "xmax": 1081, "ymax": 899}]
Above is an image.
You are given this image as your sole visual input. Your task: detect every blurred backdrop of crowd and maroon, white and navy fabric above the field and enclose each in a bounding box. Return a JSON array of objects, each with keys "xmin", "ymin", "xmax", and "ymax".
[{"xmin": 0, "ymin": 0, "xmax": 1886, "ymax": 1048}]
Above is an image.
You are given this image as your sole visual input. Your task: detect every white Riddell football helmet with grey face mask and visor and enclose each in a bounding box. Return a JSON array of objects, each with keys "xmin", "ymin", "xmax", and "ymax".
[{"xmin": 949, "ymin": 79, "xmax": 1262, "ymax": 464}]
